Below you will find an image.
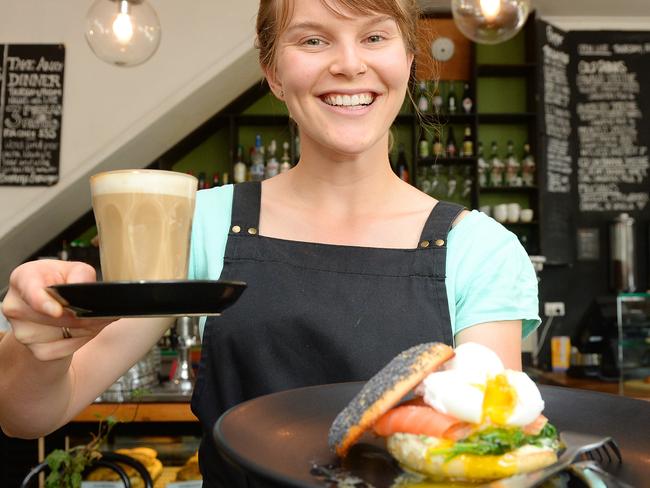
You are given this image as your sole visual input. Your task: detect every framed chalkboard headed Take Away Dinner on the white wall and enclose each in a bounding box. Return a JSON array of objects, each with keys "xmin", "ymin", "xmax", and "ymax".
[{"xmin": 0, "ymin": 44, "xmax": 65, "ymax": 186}]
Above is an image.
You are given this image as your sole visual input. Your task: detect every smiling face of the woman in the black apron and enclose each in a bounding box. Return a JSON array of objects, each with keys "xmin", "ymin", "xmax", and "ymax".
[{"xmin": 267, "ymin": 0, "xmax": 413, "ymax": 155}]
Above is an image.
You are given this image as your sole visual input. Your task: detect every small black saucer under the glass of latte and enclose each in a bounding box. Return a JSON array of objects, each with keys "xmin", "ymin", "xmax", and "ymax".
[{"xmin": 48, "ymin": 280, "xmax": 246, "ymax": 318}]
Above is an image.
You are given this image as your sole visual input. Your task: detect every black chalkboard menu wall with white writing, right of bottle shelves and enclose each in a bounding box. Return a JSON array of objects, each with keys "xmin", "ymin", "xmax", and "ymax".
[{"xmin": 537, "ymin": 21, "xmax": 650, "ymax": 263}]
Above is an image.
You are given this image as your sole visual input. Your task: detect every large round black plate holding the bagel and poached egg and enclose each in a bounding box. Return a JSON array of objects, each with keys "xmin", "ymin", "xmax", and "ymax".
[{"xmin": 213, "ymin": 383, "xmax": 650, "ymax": 488}]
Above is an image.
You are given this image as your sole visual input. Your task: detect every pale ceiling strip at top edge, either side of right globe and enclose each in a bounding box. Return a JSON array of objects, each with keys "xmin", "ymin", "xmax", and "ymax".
[{"xmin": 419, "ymin": 0, "xmax": 650, "ymax": 16}]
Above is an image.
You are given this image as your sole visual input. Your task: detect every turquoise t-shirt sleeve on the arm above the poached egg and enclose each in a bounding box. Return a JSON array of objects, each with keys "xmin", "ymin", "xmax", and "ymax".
[{"xmin": 447, "ymin": 211, "xmax": 541, "ymax": 337}]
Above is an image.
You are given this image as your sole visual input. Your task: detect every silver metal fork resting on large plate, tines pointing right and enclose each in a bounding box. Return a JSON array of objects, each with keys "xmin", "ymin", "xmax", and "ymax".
[{"xmin": 482, "ymin": 432, "xmax": 623, "ymax": 488}]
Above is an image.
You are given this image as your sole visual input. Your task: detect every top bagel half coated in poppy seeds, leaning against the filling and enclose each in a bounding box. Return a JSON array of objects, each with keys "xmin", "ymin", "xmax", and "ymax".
[{"xmin": 328, "ymin": 342, "xmax": 454, "ymax": 457}]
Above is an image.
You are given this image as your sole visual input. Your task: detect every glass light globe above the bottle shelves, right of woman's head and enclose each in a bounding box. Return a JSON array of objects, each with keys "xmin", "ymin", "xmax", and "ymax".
[{"xmin": 451, "ymin": 0, "xmax": 530, "ymax": 44}]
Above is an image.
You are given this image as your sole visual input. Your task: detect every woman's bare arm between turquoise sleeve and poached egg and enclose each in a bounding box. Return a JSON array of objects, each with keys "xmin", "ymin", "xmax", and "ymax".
[{"xmin": 456, "ymin": 320, "xmax": 521, "ymax": 371}]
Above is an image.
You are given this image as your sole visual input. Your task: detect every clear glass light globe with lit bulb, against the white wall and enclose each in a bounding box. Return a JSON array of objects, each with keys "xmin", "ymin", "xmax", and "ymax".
[{"xmin": 86, "ymin": 0, "xmax": 160, "ymax": 66}]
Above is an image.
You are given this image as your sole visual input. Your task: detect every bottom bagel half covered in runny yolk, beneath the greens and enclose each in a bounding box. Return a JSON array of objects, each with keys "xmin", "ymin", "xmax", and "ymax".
[{"xmin": 386, "ymin": 433, "xmax": 557, "ymax": 483}]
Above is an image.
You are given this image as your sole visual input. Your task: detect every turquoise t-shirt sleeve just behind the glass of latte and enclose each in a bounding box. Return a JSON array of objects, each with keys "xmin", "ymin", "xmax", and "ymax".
[{"xmin": 188, "ymin": 185, "xmax": 233, "ymax": 280}]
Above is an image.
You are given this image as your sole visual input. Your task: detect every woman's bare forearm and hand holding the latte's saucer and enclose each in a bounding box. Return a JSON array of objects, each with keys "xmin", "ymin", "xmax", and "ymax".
[{"xmin": 0, "ymin": 261, "xmax": 173, "ymax": 438}]
